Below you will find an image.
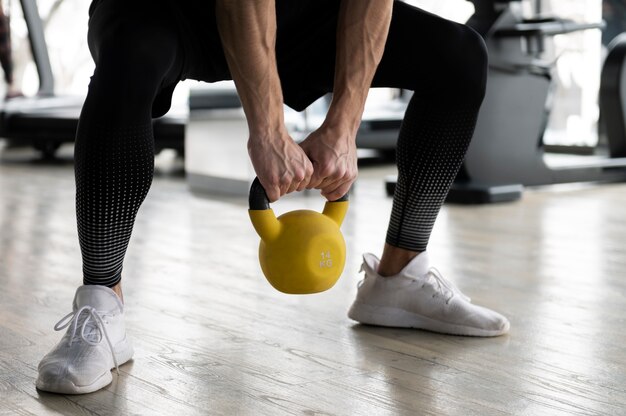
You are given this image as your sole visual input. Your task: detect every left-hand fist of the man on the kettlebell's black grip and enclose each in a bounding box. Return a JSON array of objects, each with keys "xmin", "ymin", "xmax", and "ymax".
[{"xmin": 248, "ymin": 129, "xmax": 313, "ymax": 202}]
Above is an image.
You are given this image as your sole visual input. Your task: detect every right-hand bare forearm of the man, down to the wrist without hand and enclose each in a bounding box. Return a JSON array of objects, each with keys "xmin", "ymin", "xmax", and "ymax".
[{"xmin": 326, "ymin": 0, "xmax": 393, "ymax": 134}]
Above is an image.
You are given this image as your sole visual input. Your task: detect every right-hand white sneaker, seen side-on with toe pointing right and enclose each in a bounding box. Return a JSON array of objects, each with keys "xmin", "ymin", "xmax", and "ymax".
[{"xmin": 348, "ymin": 252, "xmax": 510, "ymax": 337}]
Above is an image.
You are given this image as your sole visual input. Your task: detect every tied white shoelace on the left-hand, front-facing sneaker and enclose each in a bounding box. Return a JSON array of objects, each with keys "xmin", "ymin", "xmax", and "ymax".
[{"xmin": 54, "ymin": 305, "xmax": 120, "ymax": 375}]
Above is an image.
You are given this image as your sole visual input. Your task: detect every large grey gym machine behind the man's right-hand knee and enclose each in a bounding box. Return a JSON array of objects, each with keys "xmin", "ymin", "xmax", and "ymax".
[{"xmin": 387, "ymin": 0, "xmax": 626, "ymax": 203}]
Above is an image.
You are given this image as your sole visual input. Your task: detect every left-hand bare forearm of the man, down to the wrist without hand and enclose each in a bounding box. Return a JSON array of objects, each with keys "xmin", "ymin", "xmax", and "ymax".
[{"xmin": 216, "ymin": 0, "xmax": 284, "ymax": 138}]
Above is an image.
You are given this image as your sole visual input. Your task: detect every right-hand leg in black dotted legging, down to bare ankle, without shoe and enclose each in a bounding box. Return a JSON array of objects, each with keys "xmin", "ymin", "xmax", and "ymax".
[{"xmin": 374, "ymin": 4, "xmax": 487, "ymax": 276}]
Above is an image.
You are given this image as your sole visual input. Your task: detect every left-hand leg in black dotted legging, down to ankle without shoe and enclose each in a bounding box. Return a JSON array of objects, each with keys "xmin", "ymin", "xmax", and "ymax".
[{"xmin": 75, "ymin": 0, "xmax": 182, "ymax": 288}]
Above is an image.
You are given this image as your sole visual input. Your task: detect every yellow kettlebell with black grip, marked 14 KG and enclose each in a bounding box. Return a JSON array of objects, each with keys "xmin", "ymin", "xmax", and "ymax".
[{"xmin": 248, "ymin": 178, "xmax": 348, "ymax": 294}]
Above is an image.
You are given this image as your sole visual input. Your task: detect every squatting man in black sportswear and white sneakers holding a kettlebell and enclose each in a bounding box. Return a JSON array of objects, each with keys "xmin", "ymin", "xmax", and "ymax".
[{"xmin": 37, "ymin": 0, "xmax": 509, "ymax": 393}]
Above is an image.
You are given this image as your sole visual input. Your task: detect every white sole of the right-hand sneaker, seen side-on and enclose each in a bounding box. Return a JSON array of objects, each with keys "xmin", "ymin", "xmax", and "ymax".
[{"xmin": 348, "ymin": 302, "xmax": 510, "ymax": 337}]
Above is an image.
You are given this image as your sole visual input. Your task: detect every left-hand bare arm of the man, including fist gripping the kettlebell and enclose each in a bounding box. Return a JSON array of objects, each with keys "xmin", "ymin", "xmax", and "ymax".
[{"xmin": 216, "ymin": 0, "xmax": 313, "ymax": 201}]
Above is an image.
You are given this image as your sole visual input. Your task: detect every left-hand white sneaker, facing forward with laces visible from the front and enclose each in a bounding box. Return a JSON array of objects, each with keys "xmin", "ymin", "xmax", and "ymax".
[{"xmin": 36, "ymin": 286, "xmax": 133, "ymax": 394}]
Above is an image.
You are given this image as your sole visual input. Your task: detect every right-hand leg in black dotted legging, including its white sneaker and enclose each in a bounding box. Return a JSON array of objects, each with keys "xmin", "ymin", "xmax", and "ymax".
[{"xmin": 348, "ymin": 3, "xmax": 509, "ymax": 336}]
